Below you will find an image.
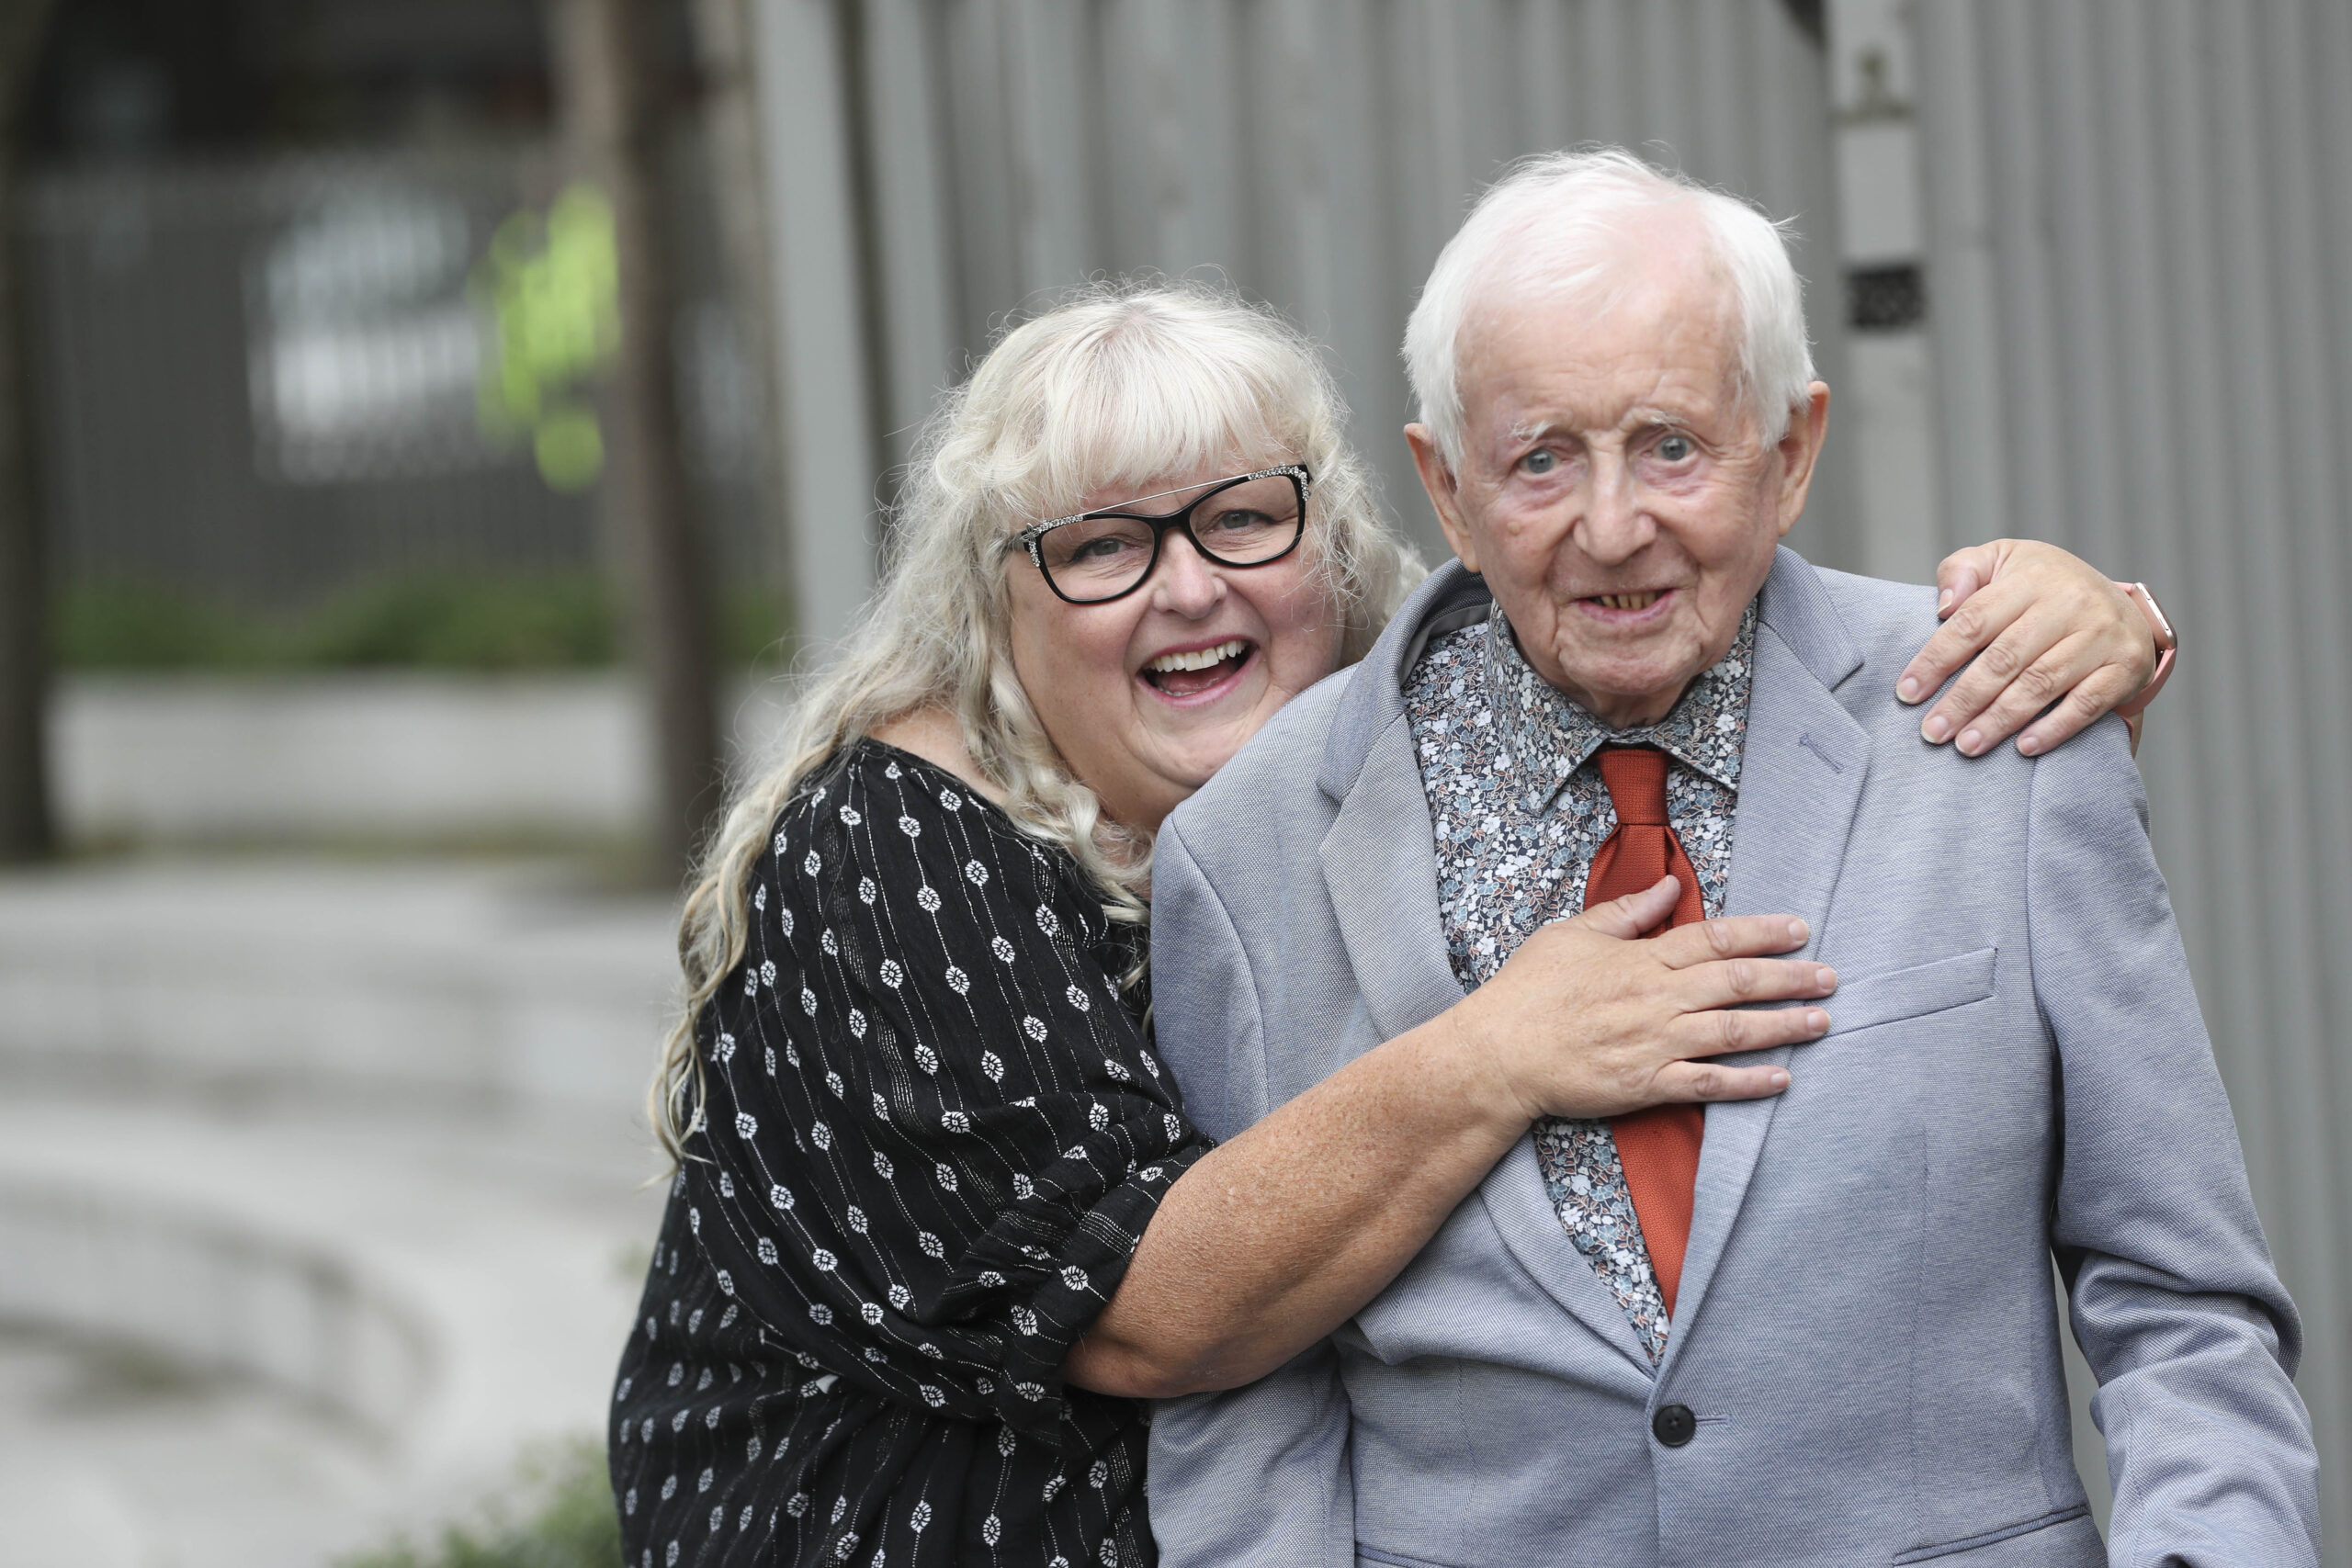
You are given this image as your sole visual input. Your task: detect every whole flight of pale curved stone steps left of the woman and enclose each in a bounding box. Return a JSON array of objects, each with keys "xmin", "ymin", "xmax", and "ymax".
[{"xmin": 0, "ymin": 858, "xmax": 675, "ymax": 1568}]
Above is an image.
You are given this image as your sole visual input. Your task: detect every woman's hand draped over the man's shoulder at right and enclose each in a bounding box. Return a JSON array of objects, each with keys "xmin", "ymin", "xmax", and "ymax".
[{"xmin": 1895, "ymin": 538, "xmax": 2157, "ymax": 757}]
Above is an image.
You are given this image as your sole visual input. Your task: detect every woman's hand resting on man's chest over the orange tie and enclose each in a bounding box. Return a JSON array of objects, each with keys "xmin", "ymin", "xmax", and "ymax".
[{"xmin": 1446, "ymin": 877, "xmax": 1837, "ymax": 1122}]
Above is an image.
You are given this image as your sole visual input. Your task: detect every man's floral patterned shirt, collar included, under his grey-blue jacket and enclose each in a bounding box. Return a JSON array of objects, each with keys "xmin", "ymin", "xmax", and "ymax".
[{"xmin": 1404, "ymin": 604, "xmax": 1757, "ymax": 1363}]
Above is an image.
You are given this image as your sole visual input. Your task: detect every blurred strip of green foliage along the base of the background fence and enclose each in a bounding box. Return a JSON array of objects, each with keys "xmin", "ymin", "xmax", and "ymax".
[{"xmin": 51, "ymin": 571, "xmax": 786, "ymax": 672}]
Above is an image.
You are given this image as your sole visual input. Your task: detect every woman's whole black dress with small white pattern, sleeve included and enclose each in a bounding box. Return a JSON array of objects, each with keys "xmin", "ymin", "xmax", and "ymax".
[{"xmin": 609, "ymin": 740, "xmax": 1209, "ymax": 1568}]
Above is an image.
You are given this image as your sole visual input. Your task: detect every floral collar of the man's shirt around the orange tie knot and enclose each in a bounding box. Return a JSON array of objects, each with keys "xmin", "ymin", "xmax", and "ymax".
[{"xmin": 1484, "ymin": 600, "xmax": 1757, "ymax": 813}]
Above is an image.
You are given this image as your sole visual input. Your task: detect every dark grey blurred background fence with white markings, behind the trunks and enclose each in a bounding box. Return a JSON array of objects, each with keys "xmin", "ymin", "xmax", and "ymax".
[{"xmin": 14, "ymin": 146, "xmax": 772, "ymax": 604}]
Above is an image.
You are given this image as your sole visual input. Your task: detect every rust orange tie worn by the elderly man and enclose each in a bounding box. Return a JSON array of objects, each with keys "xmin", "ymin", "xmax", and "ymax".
[{"xmin": 1585, "ymin": 745, "xmax": 1708, "ymax": 1316}]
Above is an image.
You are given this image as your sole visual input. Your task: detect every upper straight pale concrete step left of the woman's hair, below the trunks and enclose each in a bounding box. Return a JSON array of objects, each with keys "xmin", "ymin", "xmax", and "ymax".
[{"xmin": 0, "ymin": 858, "xmax": 677, "ymax": 1114}]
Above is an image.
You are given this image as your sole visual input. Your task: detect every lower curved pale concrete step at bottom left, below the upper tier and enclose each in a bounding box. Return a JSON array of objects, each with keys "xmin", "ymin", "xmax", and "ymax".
[{"xmin": 0, "ymin": 1096, "xmax": 661, "ymax": 1568}]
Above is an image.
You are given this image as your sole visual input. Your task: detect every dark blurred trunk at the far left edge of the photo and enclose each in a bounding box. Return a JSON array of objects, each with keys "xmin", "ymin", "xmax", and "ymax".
[{"xmin": 0, "ymin": 0, "xmax": 56, "ymax": 863}]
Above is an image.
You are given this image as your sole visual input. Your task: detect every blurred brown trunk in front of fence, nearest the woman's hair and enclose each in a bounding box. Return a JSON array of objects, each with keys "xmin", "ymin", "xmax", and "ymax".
[{"xmin": 548, "ymin": 0, "xmax": 722, "ymax": 877}]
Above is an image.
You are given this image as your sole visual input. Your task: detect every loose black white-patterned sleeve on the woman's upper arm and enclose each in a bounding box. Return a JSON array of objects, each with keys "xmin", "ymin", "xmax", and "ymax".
[{"xmin": 687, "ymin": 745, "xmax": 1206, "ymax": 1437}]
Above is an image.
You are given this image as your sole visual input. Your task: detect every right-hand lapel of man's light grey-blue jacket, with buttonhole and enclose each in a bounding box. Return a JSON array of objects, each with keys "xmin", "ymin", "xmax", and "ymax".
[{"xmin": 1668, "ymin": 550, "xmax": 1870, "ymax": 1363}]
